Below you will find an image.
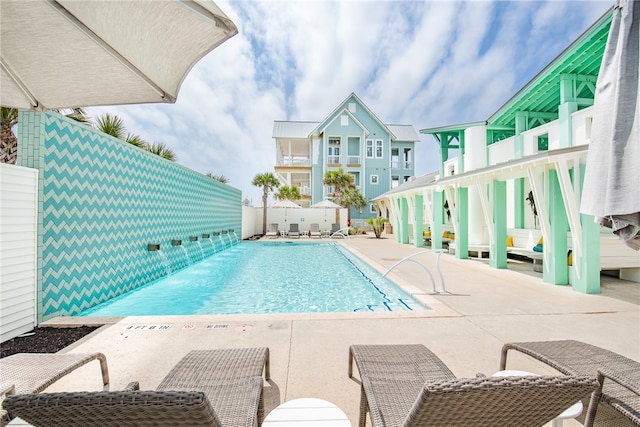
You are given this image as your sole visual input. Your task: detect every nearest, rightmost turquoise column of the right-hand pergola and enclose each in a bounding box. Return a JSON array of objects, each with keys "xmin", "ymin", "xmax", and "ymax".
[{"xmin": 571, "ymin": 165, "xmax": 600, "ymax": 294}]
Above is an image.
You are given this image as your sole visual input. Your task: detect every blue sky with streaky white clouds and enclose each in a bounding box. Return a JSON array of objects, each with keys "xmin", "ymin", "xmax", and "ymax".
[{"xmin": 88, "ymin": 0, "xmax": 614, "ymax": 206}]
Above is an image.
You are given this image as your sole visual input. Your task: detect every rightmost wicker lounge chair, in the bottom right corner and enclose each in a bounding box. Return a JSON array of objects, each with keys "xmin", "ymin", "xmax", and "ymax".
[{"xmin": 500, "ymin": 340, "xmax": 640, "ymax": 427}]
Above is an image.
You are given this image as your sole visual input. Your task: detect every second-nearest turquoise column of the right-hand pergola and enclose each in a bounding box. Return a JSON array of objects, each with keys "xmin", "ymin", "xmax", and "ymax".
[{"xmin": 542, "ymin": 170, "xmax": 569, "ymax": 285}]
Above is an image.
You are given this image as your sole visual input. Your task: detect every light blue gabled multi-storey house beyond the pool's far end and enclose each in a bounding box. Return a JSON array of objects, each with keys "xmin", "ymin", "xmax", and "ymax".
[{"xmin": 272, "ymin": 93, "xmax": 420, "ymax": 225}]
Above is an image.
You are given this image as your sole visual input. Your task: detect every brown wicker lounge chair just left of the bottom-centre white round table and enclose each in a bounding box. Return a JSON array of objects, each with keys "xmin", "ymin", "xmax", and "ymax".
[{"xmin": 4, "ymin": 347, "xmax": 270, "ymax": 427}]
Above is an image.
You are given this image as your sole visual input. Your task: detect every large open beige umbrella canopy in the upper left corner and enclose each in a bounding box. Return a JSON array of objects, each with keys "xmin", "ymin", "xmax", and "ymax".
[{"xmin": 0, "ymin": 0, "xmax": 238, "ymax": 110}]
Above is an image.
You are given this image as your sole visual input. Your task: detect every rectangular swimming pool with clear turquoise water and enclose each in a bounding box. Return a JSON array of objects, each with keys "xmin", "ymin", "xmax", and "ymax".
[{"xmin": 78, "ymin": 242, "xmax": 427, "ymax": 316}]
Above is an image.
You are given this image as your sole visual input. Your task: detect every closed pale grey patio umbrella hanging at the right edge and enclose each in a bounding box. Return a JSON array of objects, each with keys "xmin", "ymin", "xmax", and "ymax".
[{"xmin": 580, "ymin": 0, "xmax": 640, "ymax": 250}]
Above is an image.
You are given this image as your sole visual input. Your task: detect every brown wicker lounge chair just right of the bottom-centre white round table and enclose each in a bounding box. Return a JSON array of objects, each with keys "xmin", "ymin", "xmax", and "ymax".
[{"xmin": 349, "ymin": 345, "xmax": 597, "ymax": 427}]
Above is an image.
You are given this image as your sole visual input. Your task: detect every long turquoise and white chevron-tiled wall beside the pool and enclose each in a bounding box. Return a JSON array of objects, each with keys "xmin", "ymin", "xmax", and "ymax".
[{"xmin": 18, "ymin": 111, "xmax": 242, "ymax": 321}]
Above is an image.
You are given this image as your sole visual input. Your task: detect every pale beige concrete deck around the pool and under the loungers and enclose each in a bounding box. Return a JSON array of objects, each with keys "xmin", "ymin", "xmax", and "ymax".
[{"xmin": 16, "ymin": 233, "xmax": 640, "ymax": 426}]
